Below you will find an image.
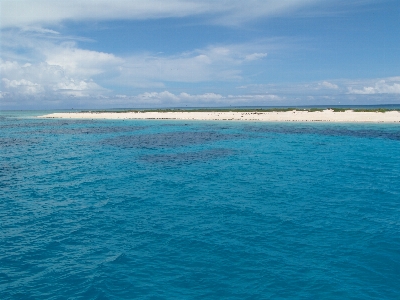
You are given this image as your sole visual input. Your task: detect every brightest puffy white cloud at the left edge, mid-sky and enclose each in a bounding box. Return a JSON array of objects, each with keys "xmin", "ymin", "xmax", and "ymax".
[{"xmin": 0, "ymin": 29, "xmax": 123, "ymax": 99}]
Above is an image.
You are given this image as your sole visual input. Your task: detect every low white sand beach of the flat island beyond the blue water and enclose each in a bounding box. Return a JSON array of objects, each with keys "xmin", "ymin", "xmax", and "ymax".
[{"xmin": 39, "ymin": 109, "xmax": 400, "ymax": 123}]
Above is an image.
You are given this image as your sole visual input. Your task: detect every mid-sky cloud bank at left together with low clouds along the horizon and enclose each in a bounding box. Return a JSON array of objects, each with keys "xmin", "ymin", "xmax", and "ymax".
[{"xmin": 0, "ymin": 28, "xmax": 400, "ymax": 108}]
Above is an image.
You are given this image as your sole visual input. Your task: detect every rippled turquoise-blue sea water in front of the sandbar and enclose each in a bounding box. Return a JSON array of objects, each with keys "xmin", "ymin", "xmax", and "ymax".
[{"xmin": 0, "ymin": 112, "xmax": 400, "ymax": 299}]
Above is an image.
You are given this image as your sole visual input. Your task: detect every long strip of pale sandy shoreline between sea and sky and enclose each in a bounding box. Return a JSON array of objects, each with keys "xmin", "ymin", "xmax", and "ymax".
[{"xmin": 38, "ymin": 108, "xmax": 400, "ymax": 123}]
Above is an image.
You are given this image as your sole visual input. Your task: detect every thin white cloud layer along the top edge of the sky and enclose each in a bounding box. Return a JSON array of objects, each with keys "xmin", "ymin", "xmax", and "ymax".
[{"xmin": 1, "ymin": 0, "xmax": 321, "ymax": 28}]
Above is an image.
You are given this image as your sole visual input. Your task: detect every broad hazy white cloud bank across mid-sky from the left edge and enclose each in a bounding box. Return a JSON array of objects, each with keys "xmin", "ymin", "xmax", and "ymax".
[{"xmin": 0, "ymin": 29, "xmax": 268, "ymax": 97}]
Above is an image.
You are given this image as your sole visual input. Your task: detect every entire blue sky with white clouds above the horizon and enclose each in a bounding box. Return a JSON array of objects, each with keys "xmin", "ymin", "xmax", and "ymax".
[{"xmin": 0, "ymin": 0, "xmax": 400, "ymax": 109}]
